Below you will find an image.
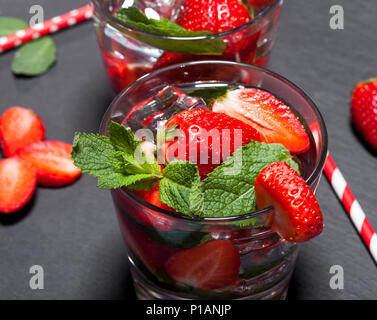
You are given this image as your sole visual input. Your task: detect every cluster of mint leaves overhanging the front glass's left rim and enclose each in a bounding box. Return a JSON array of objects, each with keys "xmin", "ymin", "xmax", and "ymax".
[{"xmin": 71, "ymin": 122, "xmax": 161, "ymax": 190}]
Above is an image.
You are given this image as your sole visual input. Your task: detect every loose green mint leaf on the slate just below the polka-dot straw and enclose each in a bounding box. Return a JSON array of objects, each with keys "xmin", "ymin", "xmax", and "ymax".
[{"xmin": 11, "ymin": 37, "xmax": 56, "ymax": 76}]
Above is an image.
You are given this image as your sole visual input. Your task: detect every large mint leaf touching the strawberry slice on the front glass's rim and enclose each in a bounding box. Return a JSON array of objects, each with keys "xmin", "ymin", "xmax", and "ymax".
[{"xmin": 202, "ymin": 141, "xmax": 300, "ymax": 217}]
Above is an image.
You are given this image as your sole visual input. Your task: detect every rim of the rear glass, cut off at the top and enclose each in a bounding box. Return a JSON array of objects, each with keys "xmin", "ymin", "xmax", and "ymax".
[{"xmin": 97, "ymin": 0, "xmax": 283, "ymax": 41}]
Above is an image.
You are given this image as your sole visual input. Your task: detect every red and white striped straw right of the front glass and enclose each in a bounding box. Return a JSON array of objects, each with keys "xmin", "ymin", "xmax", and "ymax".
[{"xmin": 324, "ymin": 154, "xmax": 377, "ymax": 263}]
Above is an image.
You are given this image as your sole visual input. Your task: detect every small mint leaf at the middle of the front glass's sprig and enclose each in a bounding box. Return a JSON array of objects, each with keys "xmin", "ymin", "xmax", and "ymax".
[{"xmin": 160, "ymin": 160, "xmax": 203, "ymax": 216}]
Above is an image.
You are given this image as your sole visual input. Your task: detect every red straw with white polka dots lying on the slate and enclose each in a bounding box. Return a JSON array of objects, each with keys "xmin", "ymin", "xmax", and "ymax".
[{"xmin": 0, "ymin": 5, "xmax": 93, "ymax": 53}]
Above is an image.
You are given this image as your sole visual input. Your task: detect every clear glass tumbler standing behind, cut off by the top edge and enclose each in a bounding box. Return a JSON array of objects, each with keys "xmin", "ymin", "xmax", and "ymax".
[{"xmin": 91, "ymin": 0, "xmax": 283, "ymax": 93}]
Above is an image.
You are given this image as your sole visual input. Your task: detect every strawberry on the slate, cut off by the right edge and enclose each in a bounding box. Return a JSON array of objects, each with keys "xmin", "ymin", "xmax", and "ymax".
[{"xmin": 351, "ymin": 78, "xmax": 377, "ymax": 150}]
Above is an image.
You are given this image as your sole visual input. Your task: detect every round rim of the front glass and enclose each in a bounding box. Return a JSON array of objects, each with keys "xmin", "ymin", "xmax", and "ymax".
[{"xmin": 99, "ymin": 60, "xmax": 328, "ymax": 223}]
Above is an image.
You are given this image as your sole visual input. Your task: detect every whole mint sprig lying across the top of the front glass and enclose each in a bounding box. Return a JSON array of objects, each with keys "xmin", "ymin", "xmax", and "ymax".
[{"xmin": 72, "ymin": 122, "xmax": 299, "ymax": 217}]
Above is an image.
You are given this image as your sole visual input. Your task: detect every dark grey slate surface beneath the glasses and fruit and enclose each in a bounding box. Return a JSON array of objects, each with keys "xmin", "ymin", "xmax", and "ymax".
[{"xmin": 0, "ymin": 0, "xmax": 377, "ymax": 299}]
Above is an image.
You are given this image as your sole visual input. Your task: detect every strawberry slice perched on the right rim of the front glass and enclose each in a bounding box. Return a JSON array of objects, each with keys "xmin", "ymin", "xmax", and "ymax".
[{"xmin": 255, "ymin": 162, "xmax": 323, "ymax": 242}]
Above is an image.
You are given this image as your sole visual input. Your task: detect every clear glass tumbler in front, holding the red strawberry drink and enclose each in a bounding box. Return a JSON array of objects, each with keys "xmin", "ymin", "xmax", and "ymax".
[{"xmin": 100, "ymin": 60, "xmax": 327, "ymax": 299}]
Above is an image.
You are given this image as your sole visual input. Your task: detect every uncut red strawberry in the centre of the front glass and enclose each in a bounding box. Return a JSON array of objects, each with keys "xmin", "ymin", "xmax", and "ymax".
[{"xmin": 162, "ymin": 109, "xmax": 260, "ymax": 177}]
